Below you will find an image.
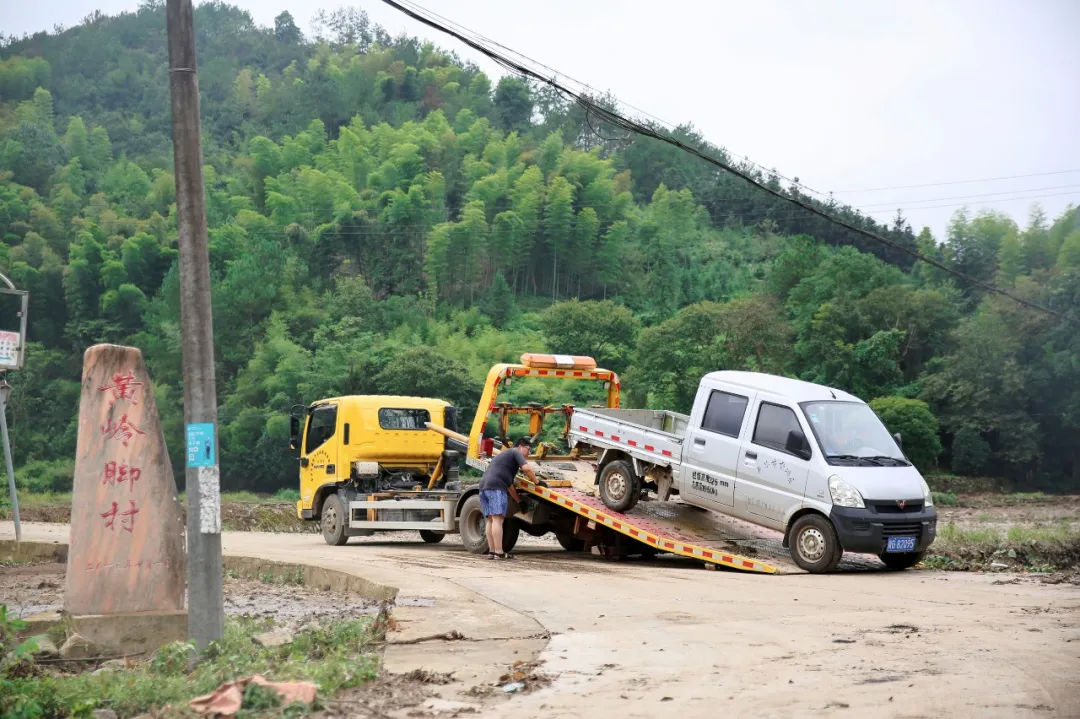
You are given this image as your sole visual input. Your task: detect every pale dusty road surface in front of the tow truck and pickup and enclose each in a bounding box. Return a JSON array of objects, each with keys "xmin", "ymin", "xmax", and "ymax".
[{"xmin": 8, "ymin": 523, "xmax": 1080, "ymax": 719}]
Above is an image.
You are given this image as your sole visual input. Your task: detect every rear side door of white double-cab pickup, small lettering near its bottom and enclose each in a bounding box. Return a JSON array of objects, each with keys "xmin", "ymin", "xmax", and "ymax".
[{"xmin": 679, "ymin": 388, "xmax": 753, "ymax": 507}]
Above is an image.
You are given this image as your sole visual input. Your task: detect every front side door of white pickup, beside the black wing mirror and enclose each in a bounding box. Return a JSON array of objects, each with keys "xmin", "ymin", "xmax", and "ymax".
[{"xmin": 735, "ymin": 398, "xmax": 810, "ymax": 529}]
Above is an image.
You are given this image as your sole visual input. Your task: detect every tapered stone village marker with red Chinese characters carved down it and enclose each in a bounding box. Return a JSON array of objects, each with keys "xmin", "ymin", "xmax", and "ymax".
[{"xmin": 64, "ymin": 344, "xmax": 187, "ymax": 651}]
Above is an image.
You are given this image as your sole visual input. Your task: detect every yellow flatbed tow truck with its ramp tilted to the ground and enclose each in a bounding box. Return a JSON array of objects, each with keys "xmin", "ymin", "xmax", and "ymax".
[{"xmin": 292, "ymin": 354, "xmax": 775, "ymax": 572}]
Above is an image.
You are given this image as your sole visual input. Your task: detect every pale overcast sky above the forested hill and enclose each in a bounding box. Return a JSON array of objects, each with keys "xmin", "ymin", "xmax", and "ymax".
[{"xmin": 0, "ymin": 0, "xmax": 1080, "ymax": 239}]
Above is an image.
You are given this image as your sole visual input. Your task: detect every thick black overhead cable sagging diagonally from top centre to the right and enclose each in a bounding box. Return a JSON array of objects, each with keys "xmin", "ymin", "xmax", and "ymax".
[{"xmin": 382, "ymin": 0, "xmax": 1062, "ymax": 317}]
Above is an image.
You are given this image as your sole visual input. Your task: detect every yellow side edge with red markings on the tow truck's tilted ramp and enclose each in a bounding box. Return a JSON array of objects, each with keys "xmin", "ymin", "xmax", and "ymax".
[{"xmin": 516, "ymin": 478, "xmax": 777, "ymax": 574}]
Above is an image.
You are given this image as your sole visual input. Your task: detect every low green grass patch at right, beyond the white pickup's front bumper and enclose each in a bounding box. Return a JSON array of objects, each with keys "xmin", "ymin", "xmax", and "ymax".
[{"xmin": 924, "ymin": 521, "xmax": 1080, "ymax": 571}]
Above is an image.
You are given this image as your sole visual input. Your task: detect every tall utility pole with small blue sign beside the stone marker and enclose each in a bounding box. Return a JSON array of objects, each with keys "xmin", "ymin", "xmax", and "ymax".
[{"xmin": 165, "ymin": 0, "xmax": 225, "ymax": 649}]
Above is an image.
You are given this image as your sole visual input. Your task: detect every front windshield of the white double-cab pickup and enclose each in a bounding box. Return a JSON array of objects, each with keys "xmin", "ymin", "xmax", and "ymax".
[{"xmin": 801, "ymin": 402, "xmax": 908, "ymax": 466}]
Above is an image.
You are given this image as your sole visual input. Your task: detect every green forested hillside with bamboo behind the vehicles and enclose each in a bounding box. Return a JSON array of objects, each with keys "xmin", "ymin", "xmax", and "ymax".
[{"xmin": 0, "ymin": 1, "xmax": 1080, "ymax": 490}]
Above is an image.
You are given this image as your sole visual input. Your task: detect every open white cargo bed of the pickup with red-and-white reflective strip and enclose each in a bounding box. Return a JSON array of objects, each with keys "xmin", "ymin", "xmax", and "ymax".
[{"xmin": 569, "ymin": 408, "xmax": 690, "ymax": 467}]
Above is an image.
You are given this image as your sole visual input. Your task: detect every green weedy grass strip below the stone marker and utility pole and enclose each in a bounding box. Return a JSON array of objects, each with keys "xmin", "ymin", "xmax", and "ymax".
[{"xmin": 0, "ymin": 618, "xmax": 381, "ymax": 717}]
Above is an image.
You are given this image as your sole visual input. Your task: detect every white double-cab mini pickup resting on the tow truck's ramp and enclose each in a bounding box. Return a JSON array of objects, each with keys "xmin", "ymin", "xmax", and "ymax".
[{"xmin": 569, "ymin": 371, "xmax": 937, "ymax": 572}]
